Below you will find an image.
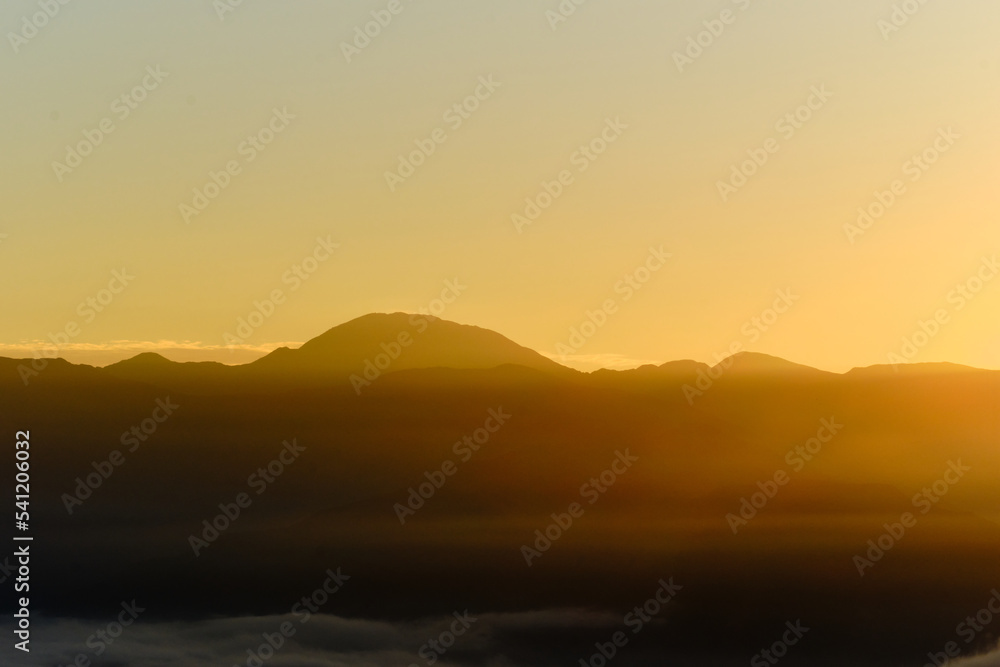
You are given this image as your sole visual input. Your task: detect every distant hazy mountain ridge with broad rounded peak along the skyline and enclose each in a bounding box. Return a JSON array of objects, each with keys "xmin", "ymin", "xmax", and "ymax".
[{"xmin": 0, "ymin": 312, "xmax": 995, "ymax": 385}]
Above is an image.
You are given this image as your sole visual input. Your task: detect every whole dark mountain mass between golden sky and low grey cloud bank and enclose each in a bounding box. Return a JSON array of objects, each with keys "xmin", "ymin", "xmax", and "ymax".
[{"xmin": 0, "ymin": 314, "xmax": 1000, "ymax": 667}]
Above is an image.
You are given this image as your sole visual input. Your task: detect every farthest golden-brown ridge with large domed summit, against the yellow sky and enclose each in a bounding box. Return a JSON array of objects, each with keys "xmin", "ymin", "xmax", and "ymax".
[{"xmin": 0, "ymin": 313, "xmax": 989, "ymax": 394}]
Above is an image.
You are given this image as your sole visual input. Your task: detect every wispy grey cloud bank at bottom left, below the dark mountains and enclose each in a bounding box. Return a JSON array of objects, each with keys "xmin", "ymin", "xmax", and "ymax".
[{"xmin": 3, "ymin": 609, "xmax": 621, "ymax": 667}]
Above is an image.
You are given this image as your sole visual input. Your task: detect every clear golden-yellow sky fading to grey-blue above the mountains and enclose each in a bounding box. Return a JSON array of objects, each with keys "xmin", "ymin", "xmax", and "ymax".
[{"xmin": 0, "ymin": 0, "xmax": 1000, "ymax": 372}]
